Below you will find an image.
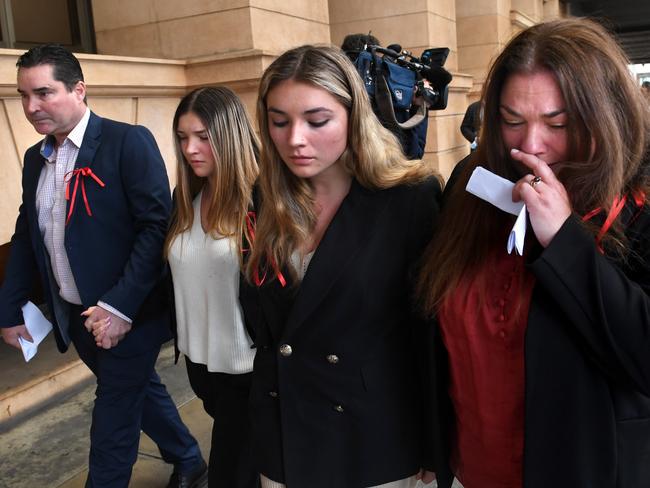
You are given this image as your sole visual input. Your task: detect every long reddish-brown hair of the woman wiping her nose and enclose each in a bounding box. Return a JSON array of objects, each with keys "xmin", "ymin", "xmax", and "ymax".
[{"xmin": 419, "ymin": 19, "xmax": 650, "ymax": 314}]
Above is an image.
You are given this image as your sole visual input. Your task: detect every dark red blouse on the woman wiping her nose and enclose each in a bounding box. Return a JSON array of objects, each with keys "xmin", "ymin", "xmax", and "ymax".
[{"xmin": 439, "ymin": 254, "xmax": 534, "ymax": 488}]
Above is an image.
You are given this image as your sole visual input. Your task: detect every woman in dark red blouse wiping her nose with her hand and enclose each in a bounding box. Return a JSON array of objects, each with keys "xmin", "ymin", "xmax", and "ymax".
[{"xmin": 420, "ymin": 19, "xmax": 650, "ymax": 488}]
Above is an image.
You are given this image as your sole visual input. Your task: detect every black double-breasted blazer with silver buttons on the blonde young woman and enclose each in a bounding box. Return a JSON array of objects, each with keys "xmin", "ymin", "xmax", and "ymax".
[{"xmin": 240, "ymin": 180, "xmax": 440, "ymax": 488}]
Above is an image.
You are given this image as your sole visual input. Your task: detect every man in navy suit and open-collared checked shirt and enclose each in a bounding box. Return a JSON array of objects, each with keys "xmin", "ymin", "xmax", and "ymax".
[{"xmin": 0, "ymin": 45, "xmax": 206, "ymax": 488}]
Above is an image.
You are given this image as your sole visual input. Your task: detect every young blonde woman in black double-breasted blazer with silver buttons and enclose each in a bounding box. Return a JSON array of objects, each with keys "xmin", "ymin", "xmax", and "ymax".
[{"xmin": 241, "ymin": 46, "xmax": 440, "ymax": 488}]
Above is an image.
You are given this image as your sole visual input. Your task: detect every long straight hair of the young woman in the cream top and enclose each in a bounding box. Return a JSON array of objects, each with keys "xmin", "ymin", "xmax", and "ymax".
[{"xmin": 165, "ymin": 87, "xmax": 259, "ymax": 262}]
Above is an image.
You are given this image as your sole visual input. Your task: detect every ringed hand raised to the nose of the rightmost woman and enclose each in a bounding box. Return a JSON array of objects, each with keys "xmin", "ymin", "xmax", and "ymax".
[{"xmin": 510, "ymin": 149, "xmax": 571, "ymax": 247}]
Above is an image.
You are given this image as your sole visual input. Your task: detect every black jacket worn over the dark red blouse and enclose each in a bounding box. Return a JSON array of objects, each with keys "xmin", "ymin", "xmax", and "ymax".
[{"xmin": 435, "ymin": 162, "xmax": 650, "ymax": 488}]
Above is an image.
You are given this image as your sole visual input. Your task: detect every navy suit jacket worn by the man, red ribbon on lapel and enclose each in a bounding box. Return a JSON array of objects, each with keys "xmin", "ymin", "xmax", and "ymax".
[{"xmin": 0, "ymin": 113, "xmax": 171, "ymax": 354}]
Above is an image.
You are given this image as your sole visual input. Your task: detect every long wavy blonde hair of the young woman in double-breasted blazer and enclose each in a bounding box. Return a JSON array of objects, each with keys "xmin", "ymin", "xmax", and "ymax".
[{"xmin": 246, "ymin": 45, "xmax": 434, "ymax": 279}]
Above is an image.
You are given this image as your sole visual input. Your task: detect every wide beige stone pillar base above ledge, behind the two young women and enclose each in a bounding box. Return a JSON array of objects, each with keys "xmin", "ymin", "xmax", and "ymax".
[{"xmin": 92, "ymin": 0, "xmax": 329, "ymax": 59}]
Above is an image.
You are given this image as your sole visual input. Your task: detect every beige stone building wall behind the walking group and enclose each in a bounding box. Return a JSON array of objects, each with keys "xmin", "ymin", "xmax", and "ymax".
[{"xmin": 0, "ymin": 0, "xmax": 562, "ymax": 244}]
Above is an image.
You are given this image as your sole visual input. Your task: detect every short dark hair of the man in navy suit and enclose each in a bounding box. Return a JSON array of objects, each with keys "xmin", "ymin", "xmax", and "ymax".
[{"xmin": 16, "ymin": 44, "xmax": 84, "ymax": 92}]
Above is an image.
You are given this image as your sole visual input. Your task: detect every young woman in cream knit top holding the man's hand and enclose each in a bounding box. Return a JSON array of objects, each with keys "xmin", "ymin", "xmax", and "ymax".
[{"xmin": 165, "ymin": 87, "xmax": 259, "ymax": 488}]
